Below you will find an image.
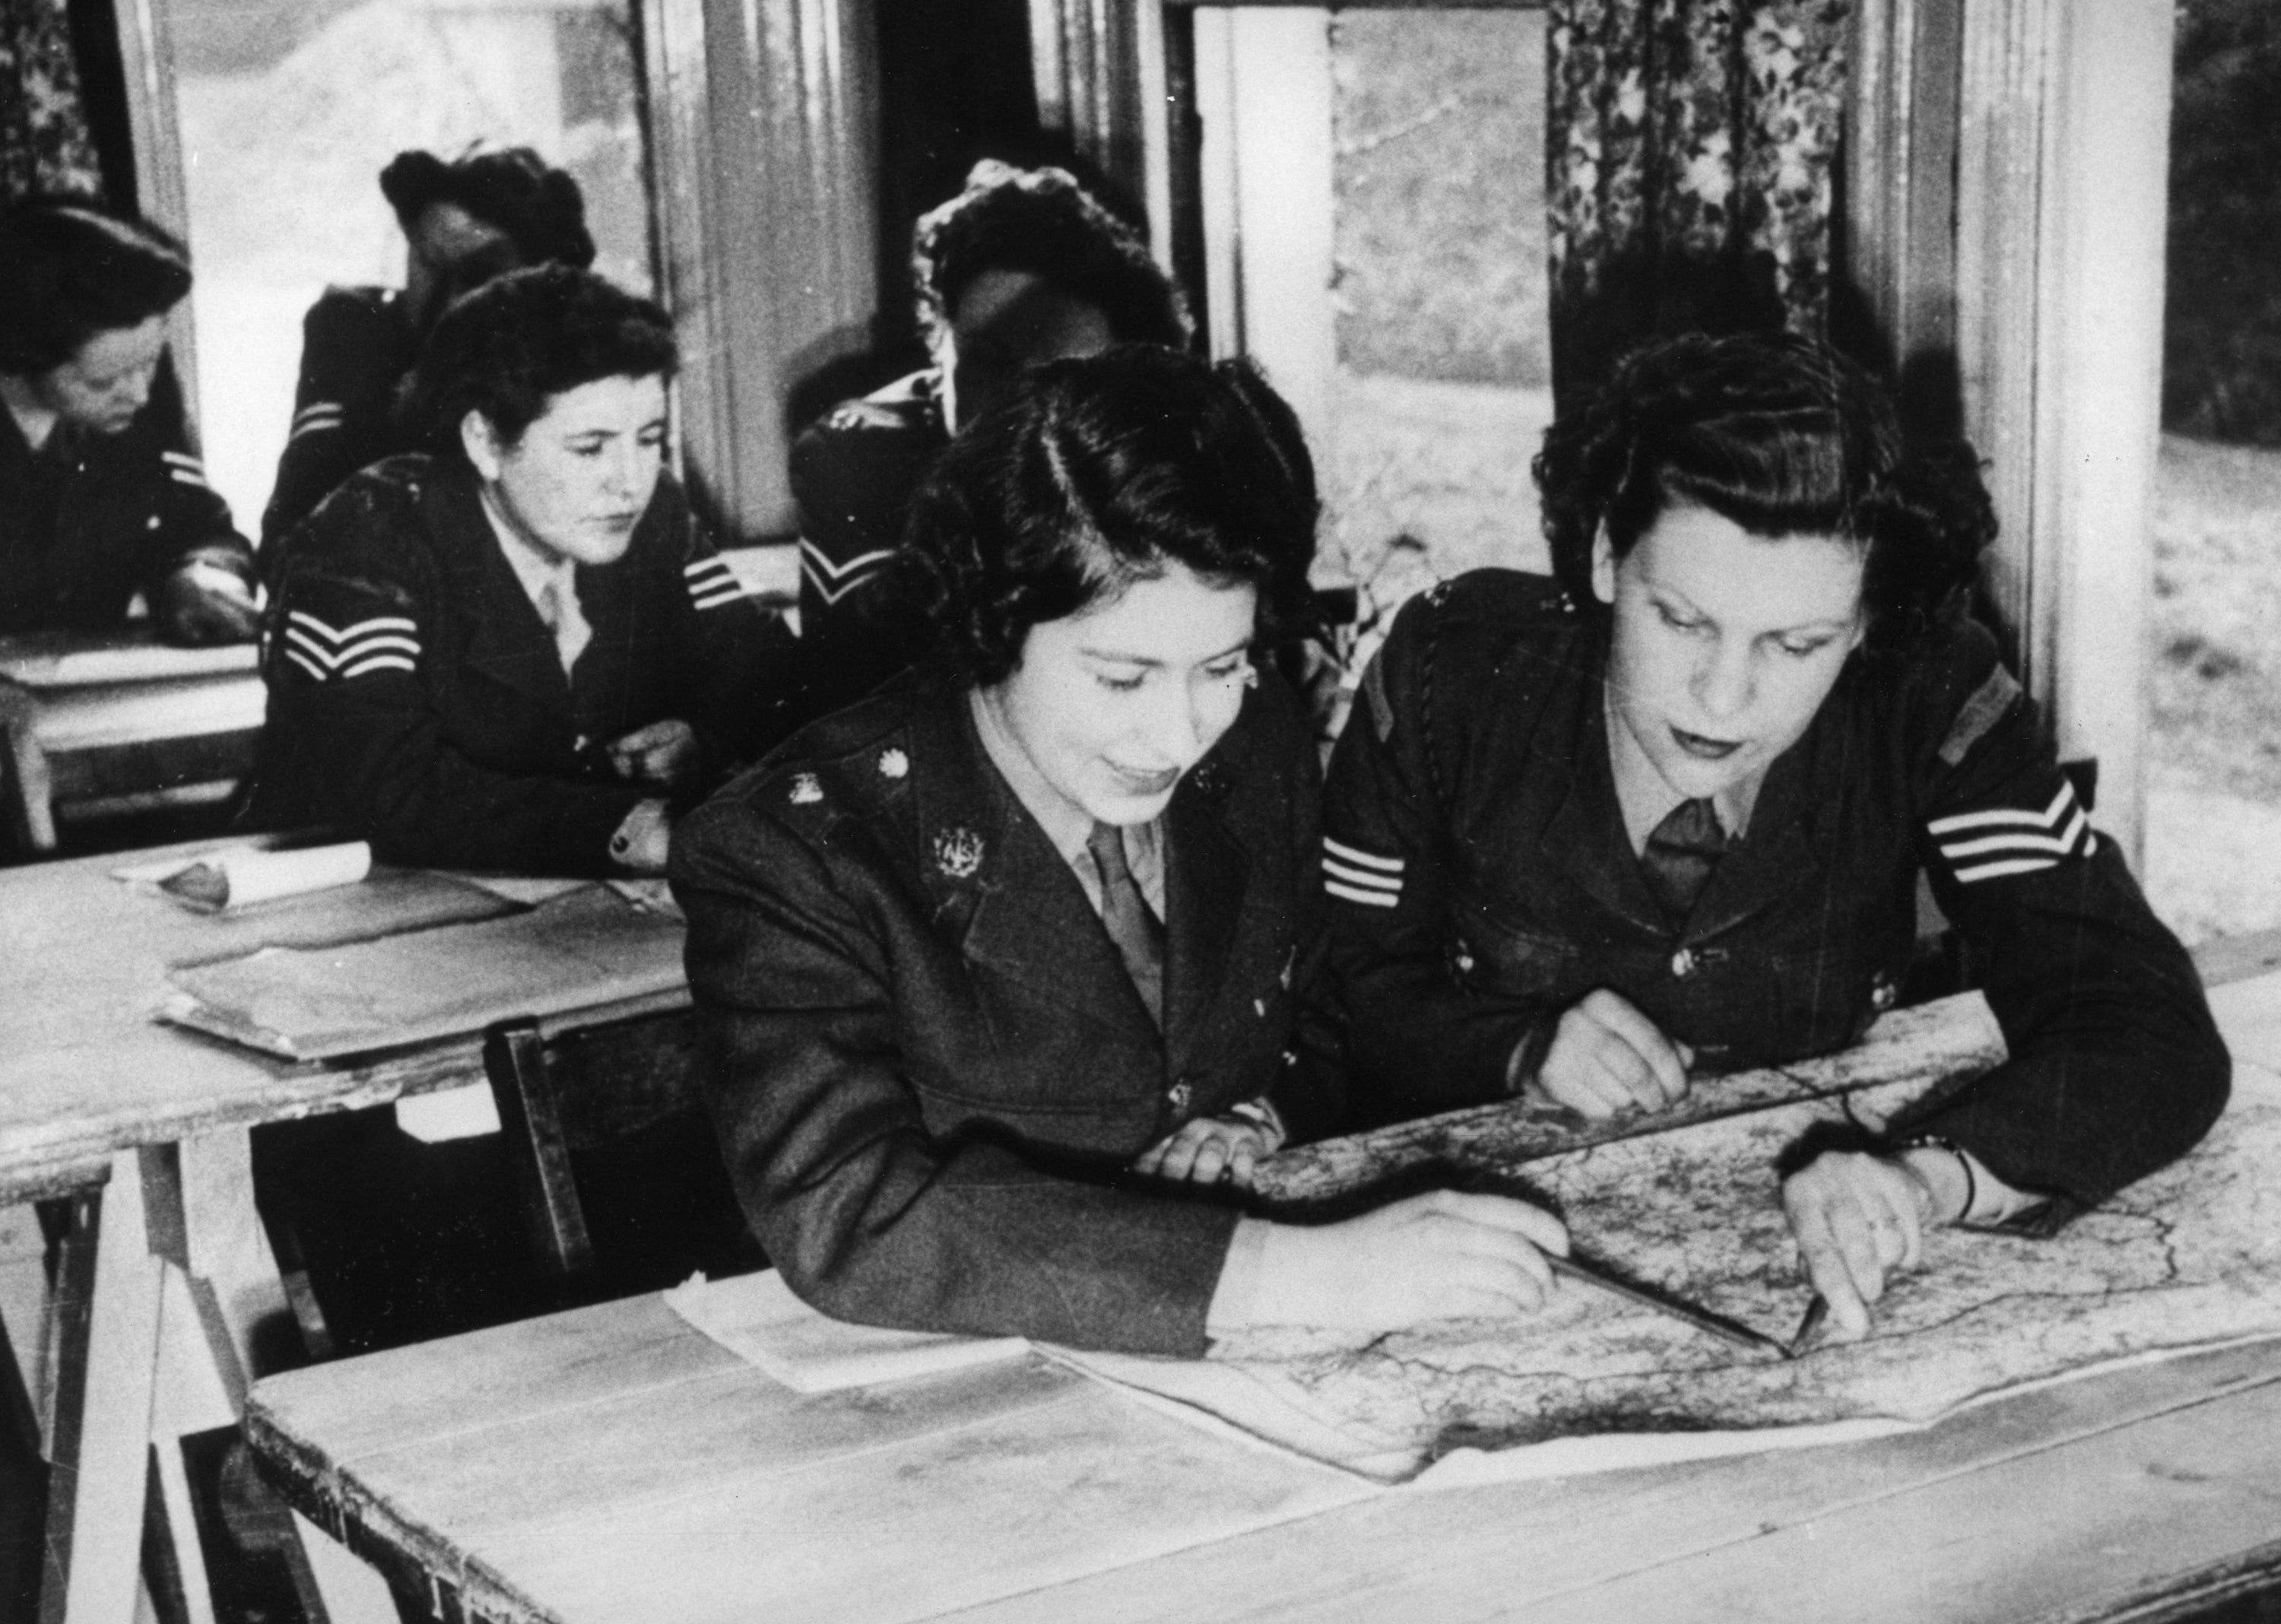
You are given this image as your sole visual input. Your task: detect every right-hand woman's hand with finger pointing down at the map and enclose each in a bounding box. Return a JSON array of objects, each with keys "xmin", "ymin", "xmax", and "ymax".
[{"xmin": 1781, "ymin": 1150, "xmax": 1937, "ymax": 1341}]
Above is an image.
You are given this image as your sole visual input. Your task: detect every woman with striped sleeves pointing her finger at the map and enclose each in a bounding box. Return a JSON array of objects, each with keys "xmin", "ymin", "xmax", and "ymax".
[{"xmin": 1323, "ymin": 335, "xmax": 2229, "ymax": 1332}]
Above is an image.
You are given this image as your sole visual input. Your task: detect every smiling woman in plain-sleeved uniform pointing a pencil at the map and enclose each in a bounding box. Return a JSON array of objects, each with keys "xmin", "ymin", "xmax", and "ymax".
[{"xmin": 673, "ymin": 347, "xmax": 1565, "ymax": 1355}]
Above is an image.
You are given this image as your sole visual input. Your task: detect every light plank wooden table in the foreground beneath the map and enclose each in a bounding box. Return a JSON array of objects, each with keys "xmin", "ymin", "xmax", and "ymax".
[{"xmin": 246, "ymin": 976, "xmax": 2281, "ymax": 1624}]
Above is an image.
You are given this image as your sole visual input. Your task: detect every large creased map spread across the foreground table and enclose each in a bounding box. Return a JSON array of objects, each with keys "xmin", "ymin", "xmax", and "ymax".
[{"xmin": 1063, "ymin": 1040, "xmax": 2281, "ymax": 1483}]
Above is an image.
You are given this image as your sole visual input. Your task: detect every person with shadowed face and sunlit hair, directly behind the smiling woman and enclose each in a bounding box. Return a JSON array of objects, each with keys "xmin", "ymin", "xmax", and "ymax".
[{"xmin": 792, "ymin": 160, "xmax": 1193, "ymax": 716}]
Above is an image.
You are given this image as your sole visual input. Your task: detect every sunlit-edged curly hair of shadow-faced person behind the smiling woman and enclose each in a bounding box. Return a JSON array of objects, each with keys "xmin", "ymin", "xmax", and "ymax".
[{"xmin": 910, "ymin": 157, "xmax": 1195, "ymax": 349}]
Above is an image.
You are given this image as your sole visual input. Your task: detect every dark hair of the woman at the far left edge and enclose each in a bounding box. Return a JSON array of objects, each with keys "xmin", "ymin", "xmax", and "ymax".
[{"xmin": 0, "ymin": 196, "xmax": 189, "ymax": 376}]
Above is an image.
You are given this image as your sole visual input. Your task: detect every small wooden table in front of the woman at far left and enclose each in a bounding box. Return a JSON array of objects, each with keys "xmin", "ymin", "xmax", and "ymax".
[{"xmin": 0, "ymin": 627, "xmax": 269, "ymax": 851}]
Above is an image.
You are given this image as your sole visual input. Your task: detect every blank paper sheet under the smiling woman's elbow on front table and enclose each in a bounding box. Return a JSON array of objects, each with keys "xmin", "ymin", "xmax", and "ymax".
[{"xmin": 666, "ymin": 1268, "xmax": 1029, "ymax": 1394}]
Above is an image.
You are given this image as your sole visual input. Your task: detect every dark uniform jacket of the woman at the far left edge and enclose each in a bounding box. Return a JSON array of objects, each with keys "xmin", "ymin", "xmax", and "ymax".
[{"xmin": 0, "ymin": 370, "xmax": 253, "ymax": 632}]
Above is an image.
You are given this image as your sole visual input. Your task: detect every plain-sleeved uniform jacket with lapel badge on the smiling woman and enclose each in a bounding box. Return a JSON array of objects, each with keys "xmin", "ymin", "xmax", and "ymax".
[{"xmin": 673, "ymin": 671, "xmax": 1321, "ymax": 1355}]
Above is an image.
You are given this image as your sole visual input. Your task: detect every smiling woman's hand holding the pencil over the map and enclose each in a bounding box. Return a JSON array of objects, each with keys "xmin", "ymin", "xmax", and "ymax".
[{"xmin": 1250, "ymin": 1191, "xmax": 1567, "ymax": 1330}]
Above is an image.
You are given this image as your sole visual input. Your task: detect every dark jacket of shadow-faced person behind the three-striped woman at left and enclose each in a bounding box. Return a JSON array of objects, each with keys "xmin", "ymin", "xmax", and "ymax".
[{"xmin": 262, "ymin": 287, "xmax": 420, "ymax": 582}]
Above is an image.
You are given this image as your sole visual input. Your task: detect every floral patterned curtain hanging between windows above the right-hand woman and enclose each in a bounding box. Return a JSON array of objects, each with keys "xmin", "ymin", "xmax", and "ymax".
[{"xmin": 1544, "ymin": 0, "xmax": 1852, "ymax": 411}]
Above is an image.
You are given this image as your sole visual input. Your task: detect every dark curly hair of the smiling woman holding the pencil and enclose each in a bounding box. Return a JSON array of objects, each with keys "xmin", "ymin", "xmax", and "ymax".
[{"xmin": 899, "ymin": 344, "xmax": 1316, "ymax": 687}]
